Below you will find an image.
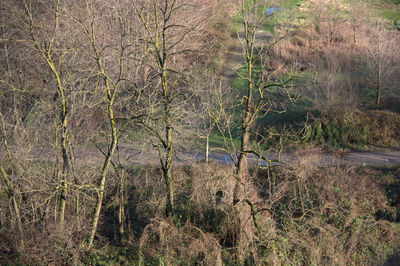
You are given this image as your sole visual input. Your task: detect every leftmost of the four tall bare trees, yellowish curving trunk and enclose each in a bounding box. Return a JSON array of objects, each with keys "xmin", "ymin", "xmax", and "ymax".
[{"xmin": 23, "ymin": 0, "xmax": 77, "ymax": 227}]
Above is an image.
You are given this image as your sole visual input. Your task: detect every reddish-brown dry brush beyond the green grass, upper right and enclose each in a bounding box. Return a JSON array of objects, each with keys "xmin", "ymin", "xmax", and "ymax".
[{"xmin": 270, "ymin": 1, "xmax": 400, "ymax": 109}]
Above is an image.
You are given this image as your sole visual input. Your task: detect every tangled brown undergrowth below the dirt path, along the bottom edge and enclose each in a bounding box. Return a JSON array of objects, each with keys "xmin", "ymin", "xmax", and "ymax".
[{"xmin": 0, "ymin": 162, "xmax": 400, "ymax": 265}]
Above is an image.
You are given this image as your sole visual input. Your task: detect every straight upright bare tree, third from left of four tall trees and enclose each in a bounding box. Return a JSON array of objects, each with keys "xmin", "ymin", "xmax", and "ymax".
[{"xmin": 131, "ymin": 0, "xmax": 212, "ymax": 216}]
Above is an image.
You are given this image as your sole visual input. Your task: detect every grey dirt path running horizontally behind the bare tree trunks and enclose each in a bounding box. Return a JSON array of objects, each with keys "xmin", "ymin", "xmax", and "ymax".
[{"xmin": 29, "ymin": 146, "xmax": 400, "ymax": 166}]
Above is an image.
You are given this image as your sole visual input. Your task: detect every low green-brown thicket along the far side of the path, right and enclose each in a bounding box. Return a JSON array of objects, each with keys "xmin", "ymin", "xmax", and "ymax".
[{"xmin": 259, "ymin": 109, "xmax": 400, "ymax": 151}]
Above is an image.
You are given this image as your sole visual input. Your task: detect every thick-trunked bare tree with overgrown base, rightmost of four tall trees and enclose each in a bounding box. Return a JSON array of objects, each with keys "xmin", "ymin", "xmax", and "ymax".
[{"xmin": 228, "ymin": 1, "xmax": 291, "ymax": 260}]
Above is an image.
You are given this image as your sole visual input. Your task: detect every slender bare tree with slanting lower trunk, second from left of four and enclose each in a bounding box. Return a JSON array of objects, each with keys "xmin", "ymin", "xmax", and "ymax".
[{"xmin": 67, "ymin": 0, "xmax": 131, "ymax": 249}]
